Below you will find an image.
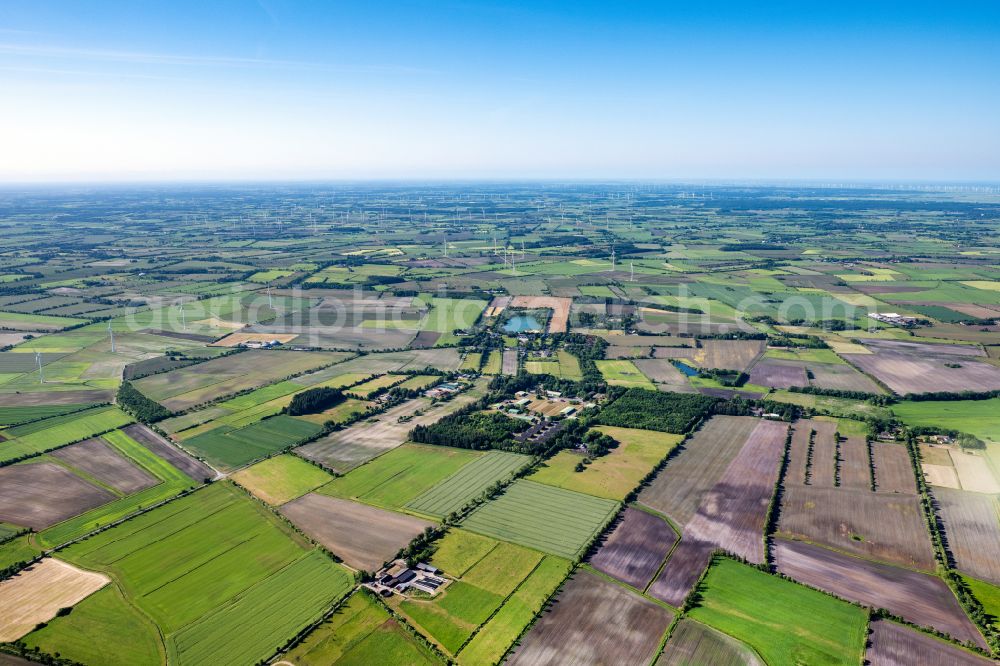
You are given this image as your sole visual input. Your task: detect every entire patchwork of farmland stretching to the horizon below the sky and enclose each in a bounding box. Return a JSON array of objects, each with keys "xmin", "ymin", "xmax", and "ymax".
[{"xmin": 0, "ymin": 183, "xmax": 1000, "ymax": 666}]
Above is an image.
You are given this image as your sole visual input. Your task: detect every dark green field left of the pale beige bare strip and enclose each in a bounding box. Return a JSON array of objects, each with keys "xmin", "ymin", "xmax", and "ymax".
[{"xmin": 184, "ymin": 414, "xmax": 323, "ymax": 470}]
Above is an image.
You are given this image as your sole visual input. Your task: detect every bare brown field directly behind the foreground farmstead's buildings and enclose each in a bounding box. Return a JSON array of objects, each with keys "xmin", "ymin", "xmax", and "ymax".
[{"xmin": 280, "ymin": 493, "xmax": 433, "ymax": 571}]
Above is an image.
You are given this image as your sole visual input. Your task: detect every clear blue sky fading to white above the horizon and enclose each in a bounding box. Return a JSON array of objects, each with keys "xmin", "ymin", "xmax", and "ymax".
[{"xmin": 0, "ymin": 0, "xmax": 1000, "ymax": 182}]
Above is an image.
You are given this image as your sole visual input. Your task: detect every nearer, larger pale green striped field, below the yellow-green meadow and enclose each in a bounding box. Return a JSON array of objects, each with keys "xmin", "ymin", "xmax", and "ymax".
[{"xmin": 462, "ymin": 480, "xmax": 618, "ymax": 560}]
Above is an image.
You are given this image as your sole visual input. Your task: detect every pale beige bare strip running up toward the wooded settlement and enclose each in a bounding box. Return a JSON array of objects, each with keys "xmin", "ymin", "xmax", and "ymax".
[{"xmin": 295, "ymin": 389, "xmax": 478, "ymax": 474}]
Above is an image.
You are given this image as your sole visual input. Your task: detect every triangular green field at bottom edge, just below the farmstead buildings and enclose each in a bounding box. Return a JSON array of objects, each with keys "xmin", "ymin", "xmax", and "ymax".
[{"xmin": 284, "ymin": 590, "xmax": 442, "ymax": 666}]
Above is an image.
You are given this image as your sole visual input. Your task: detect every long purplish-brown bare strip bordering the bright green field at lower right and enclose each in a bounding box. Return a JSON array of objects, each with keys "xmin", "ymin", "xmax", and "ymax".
[{"xmin": 774, "ymin": 539, "xmax": 986, "ymax": 647}]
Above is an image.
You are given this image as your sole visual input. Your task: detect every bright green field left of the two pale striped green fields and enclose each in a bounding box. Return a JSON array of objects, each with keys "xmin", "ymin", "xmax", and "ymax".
[{"xmin": 317, "ymin": 444, "xmax": 483, "ymax": 509}]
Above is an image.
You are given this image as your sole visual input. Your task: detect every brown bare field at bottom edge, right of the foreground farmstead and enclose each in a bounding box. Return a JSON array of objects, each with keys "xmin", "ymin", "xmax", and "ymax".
[{"xmin": 507, "ymin": 571, "xmax": 673, "ymax": 666}]
